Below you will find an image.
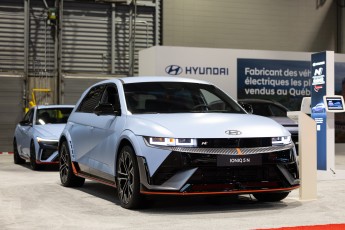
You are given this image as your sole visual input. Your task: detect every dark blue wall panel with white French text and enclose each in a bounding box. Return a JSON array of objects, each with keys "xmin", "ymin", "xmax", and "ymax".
[{"xmin": 237, "ymin": 58, "xmax": 311, "ymax": 111}]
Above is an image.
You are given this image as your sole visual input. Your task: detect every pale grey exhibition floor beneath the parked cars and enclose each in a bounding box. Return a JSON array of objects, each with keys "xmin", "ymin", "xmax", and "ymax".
[{"xmin": 0, "ymin": 152, "xmax": 345, "ymax": 230}]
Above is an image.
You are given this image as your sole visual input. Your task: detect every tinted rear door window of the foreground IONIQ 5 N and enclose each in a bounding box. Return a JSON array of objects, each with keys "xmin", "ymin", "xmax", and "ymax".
[{"xmin": 77, "ymin": 85, "xmax": 105, "ymax": 113}]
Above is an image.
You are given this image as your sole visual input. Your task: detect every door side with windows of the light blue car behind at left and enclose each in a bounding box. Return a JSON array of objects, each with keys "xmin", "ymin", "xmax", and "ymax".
[{"xmin": 17, "ymin": 108, "xmax": 35, "ymax": 157}]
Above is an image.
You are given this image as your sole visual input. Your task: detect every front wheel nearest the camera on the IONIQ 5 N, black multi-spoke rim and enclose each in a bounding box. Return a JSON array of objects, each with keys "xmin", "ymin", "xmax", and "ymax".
[{"xmin": 116, "ymin": 146, "xmax": 143, "ymax": 209}]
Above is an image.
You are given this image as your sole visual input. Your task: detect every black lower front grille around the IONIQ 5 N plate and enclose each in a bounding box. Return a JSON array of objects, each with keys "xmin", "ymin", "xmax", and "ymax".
[{"xmin": 151, "ymin": 150, "xmax": 298, "ymax": 185}]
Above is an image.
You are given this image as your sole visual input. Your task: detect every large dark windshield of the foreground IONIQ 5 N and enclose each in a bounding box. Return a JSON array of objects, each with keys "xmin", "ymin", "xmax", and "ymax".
[{"xmin": 124, "ymin": 82, "xmax": 245, "ymax": 114}]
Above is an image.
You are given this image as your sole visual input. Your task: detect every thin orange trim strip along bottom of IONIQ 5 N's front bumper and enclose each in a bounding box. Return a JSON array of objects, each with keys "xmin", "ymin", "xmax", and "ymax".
[{"xmin": 140, "ymin": 185, "xmax": 300, "ymax": 196}]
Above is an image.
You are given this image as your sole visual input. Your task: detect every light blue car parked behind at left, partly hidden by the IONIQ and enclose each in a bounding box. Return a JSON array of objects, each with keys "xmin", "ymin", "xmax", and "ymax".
[{"xmin": 13, "ymin": 105, "xmax": 74, "ymax": 170}]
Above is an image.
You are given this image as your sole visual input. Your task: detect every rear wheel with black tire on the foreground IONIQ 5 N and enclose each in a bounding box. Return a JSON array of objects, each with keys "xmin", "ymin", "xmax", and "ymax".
[{"xmin": 59, "ymin": 142, "xmax": 85, "ymax": 187}]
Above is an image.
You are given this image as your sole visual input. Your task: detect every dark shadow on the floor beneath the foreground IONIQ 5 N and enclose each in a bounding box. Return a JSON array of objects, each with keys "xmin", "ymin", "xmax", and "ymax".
[{"xmin": 76, "ymin": 181, "xmax": 302, "ymax": 215}]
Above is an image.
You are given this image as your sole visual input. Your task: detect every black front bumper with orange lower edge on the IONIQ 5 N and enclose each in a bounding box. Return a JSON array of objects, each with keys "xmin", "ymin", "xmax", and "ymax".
[{"xmin": 137, "ymin": 144, "xmax": 300, "ymax": 195}]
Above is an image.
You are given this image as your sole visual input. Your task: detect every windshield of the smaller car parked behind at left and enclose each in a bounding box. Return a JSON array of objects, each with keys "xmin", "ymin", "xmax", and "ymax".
[{"xmin": 36, "ymin": 108, "xmax": 73, "ymax": 125}]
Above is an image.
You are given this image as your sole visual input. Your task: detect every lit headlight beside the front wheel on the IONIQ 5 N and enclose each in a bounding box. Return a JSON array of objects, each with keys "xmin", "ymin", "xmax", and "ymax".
[{"xmin": 145, "ymin": 137, "xmax": 196, "ymax": 147}]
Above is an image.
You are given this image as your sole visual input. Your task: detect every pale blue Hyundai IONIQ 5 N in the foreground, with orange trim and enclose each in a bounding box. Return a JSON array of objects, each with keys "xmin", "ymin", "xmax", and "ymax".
[{"xmin": 59, "ymin": 77, "xmax": 299, "ymax": 209}]
